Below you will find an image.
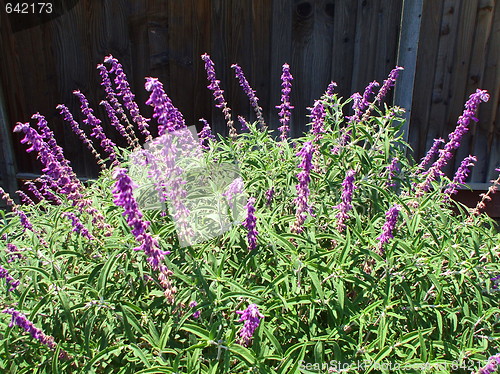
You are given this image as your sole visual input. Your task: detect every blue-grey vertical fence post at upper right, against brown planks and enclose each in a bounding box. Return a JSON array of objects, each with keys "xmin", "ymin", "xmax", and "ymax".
[{"xmin": 394, "ymin": 0, "xmax": 424, "ymax": 141}]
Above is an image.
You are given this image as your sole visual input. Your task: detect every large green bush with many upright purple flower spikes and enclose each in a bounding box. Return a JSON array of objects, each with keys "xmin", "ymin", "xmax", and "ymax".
[{"xmin": 0, "ymin": 55, "xmax": 500, "ymax": 374}]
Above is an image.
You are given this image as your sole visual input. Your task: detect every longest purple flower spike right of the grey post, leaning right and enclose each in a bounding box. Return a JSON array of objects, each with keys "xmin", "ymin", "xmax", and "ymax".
[{"xmin": 417, "ymin": 89, "xmax": 490, "ymax": 196}]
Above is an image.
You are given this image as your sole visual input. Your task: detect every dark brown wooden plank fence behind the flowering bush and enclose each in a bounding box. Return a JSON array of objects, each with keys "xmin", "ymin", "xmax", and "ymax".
[{"xmin": 0, "ymin": 0, "xmax": 500, "ymax": 191}]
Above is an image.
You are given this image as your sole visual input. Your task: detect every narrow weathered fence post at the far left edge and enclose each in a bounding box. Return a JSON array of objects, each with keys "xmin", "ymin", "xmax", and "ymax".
[{"xmin": 0, "ymin": 82, "xmax": 17, "ymax": 194}]
